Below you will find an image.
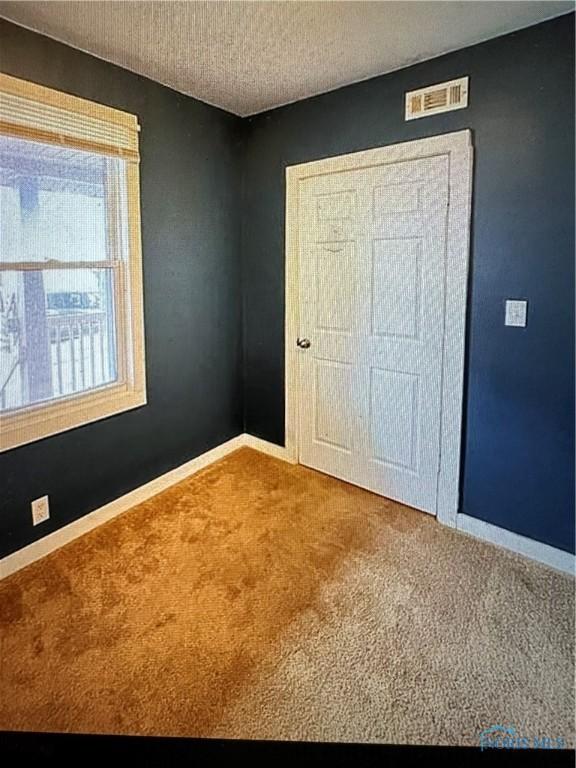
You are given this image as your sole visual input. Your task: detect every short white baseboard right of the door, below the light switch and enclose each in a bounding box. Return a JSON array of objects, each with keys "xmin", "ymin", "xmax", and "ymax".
[{"xmin": 456, "ymin": 514, "xmax": 576, "ymax": 576}]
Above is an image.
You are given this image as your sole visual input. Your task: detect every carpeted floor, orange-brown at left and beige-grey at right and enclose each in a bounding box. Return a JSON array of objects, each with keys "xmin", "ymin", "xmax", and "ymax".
[{"xmin": 0, "ymin": 449, "xmax": 574, "ymax": 746}]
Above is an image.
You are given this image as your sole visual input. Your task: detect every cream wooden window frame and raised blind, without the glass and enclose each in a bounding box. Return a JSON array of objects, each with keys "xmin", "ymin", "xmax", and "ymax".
[{"xmin": 0, "ymin": 73, "xmax": 147, "ymax": 452}]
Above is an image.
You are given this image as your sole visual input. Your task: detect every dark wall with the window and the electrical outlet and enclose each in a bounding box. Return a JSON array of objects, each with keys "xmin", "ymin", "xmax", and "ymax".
[{"xmin": 0, "ymin": 20, "xmax": 243, "ymax": 557}]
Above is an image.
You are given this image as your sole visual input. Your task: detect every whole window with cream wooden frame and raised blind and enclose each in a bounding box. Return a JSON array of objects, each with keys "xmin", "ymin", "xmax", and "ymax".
[{"xmin": 0, "ymin": 75, "xmax": 146, "ymax": 450}]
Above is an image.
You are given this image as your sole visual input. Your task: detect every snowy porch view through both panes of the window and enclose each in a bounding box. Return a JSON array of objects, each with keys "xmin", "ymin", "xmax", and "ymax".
[{"xmin": 0, "ymin": 136, "xmax": 126, "ymax": 412}]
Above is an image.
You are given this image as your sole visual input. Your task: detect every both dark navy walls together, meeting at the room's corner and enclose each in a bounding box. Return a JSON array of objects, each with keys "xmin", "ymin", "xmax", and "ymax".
[{"xmin": 0, "ymin": 15, "xmax": 574, "ymax": 557}]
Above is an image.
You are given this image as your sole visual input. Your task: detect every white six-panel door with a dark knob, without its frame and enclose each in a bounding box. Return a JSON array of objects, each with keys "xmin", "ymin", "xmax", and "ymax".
[{"xmin": 298, "ymin": 155, "xmax": 449, "ymax": 514}]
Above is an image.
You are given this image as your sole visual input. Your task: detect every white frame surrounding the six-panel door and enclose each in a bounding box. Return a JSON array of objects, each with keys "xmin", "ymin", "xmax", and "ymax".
[{"xmin": 285, "ymin": 130, "xmax": 473, "ymax": 527}]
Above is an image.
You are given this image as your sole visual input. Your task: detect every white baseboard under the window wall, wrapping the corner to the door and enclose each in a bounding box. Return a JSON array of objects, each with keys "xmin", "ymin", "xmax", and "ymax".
[{"xmin": 0, "ymin": 434, "xmax": 291, "ymax": 579}]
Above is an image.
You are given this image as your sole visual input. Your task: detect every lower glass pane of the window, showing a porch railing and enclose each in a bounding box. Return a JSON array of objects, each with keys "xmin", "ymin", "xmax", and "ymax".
[{"xmin": 0, "ymin": 269, "xmax": 118, "ymax": 411}]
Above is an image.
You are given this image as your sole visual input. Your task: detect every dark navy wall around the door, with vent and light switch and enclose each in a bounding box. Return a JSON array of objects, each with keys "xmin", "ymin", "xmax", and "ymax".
[{"xmin": 242, "ymin": 14, "xmax": 574, "ymax": 551}]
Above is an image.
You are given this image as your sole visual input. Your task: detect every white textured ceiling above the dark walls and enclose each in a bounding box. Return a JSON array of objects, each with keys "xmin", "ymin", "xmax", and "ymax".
[{"xmin": 0, "ymin": 0, "xmax": 574, "ymax": 117}]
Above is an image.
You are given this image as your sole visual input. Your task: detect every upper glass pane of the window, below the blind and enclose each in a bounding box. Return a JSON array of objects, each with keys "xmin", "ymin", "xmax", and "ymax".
[{"xmin": 0, "ymin": 136, "xmax": 124, "ymax": 263}]
